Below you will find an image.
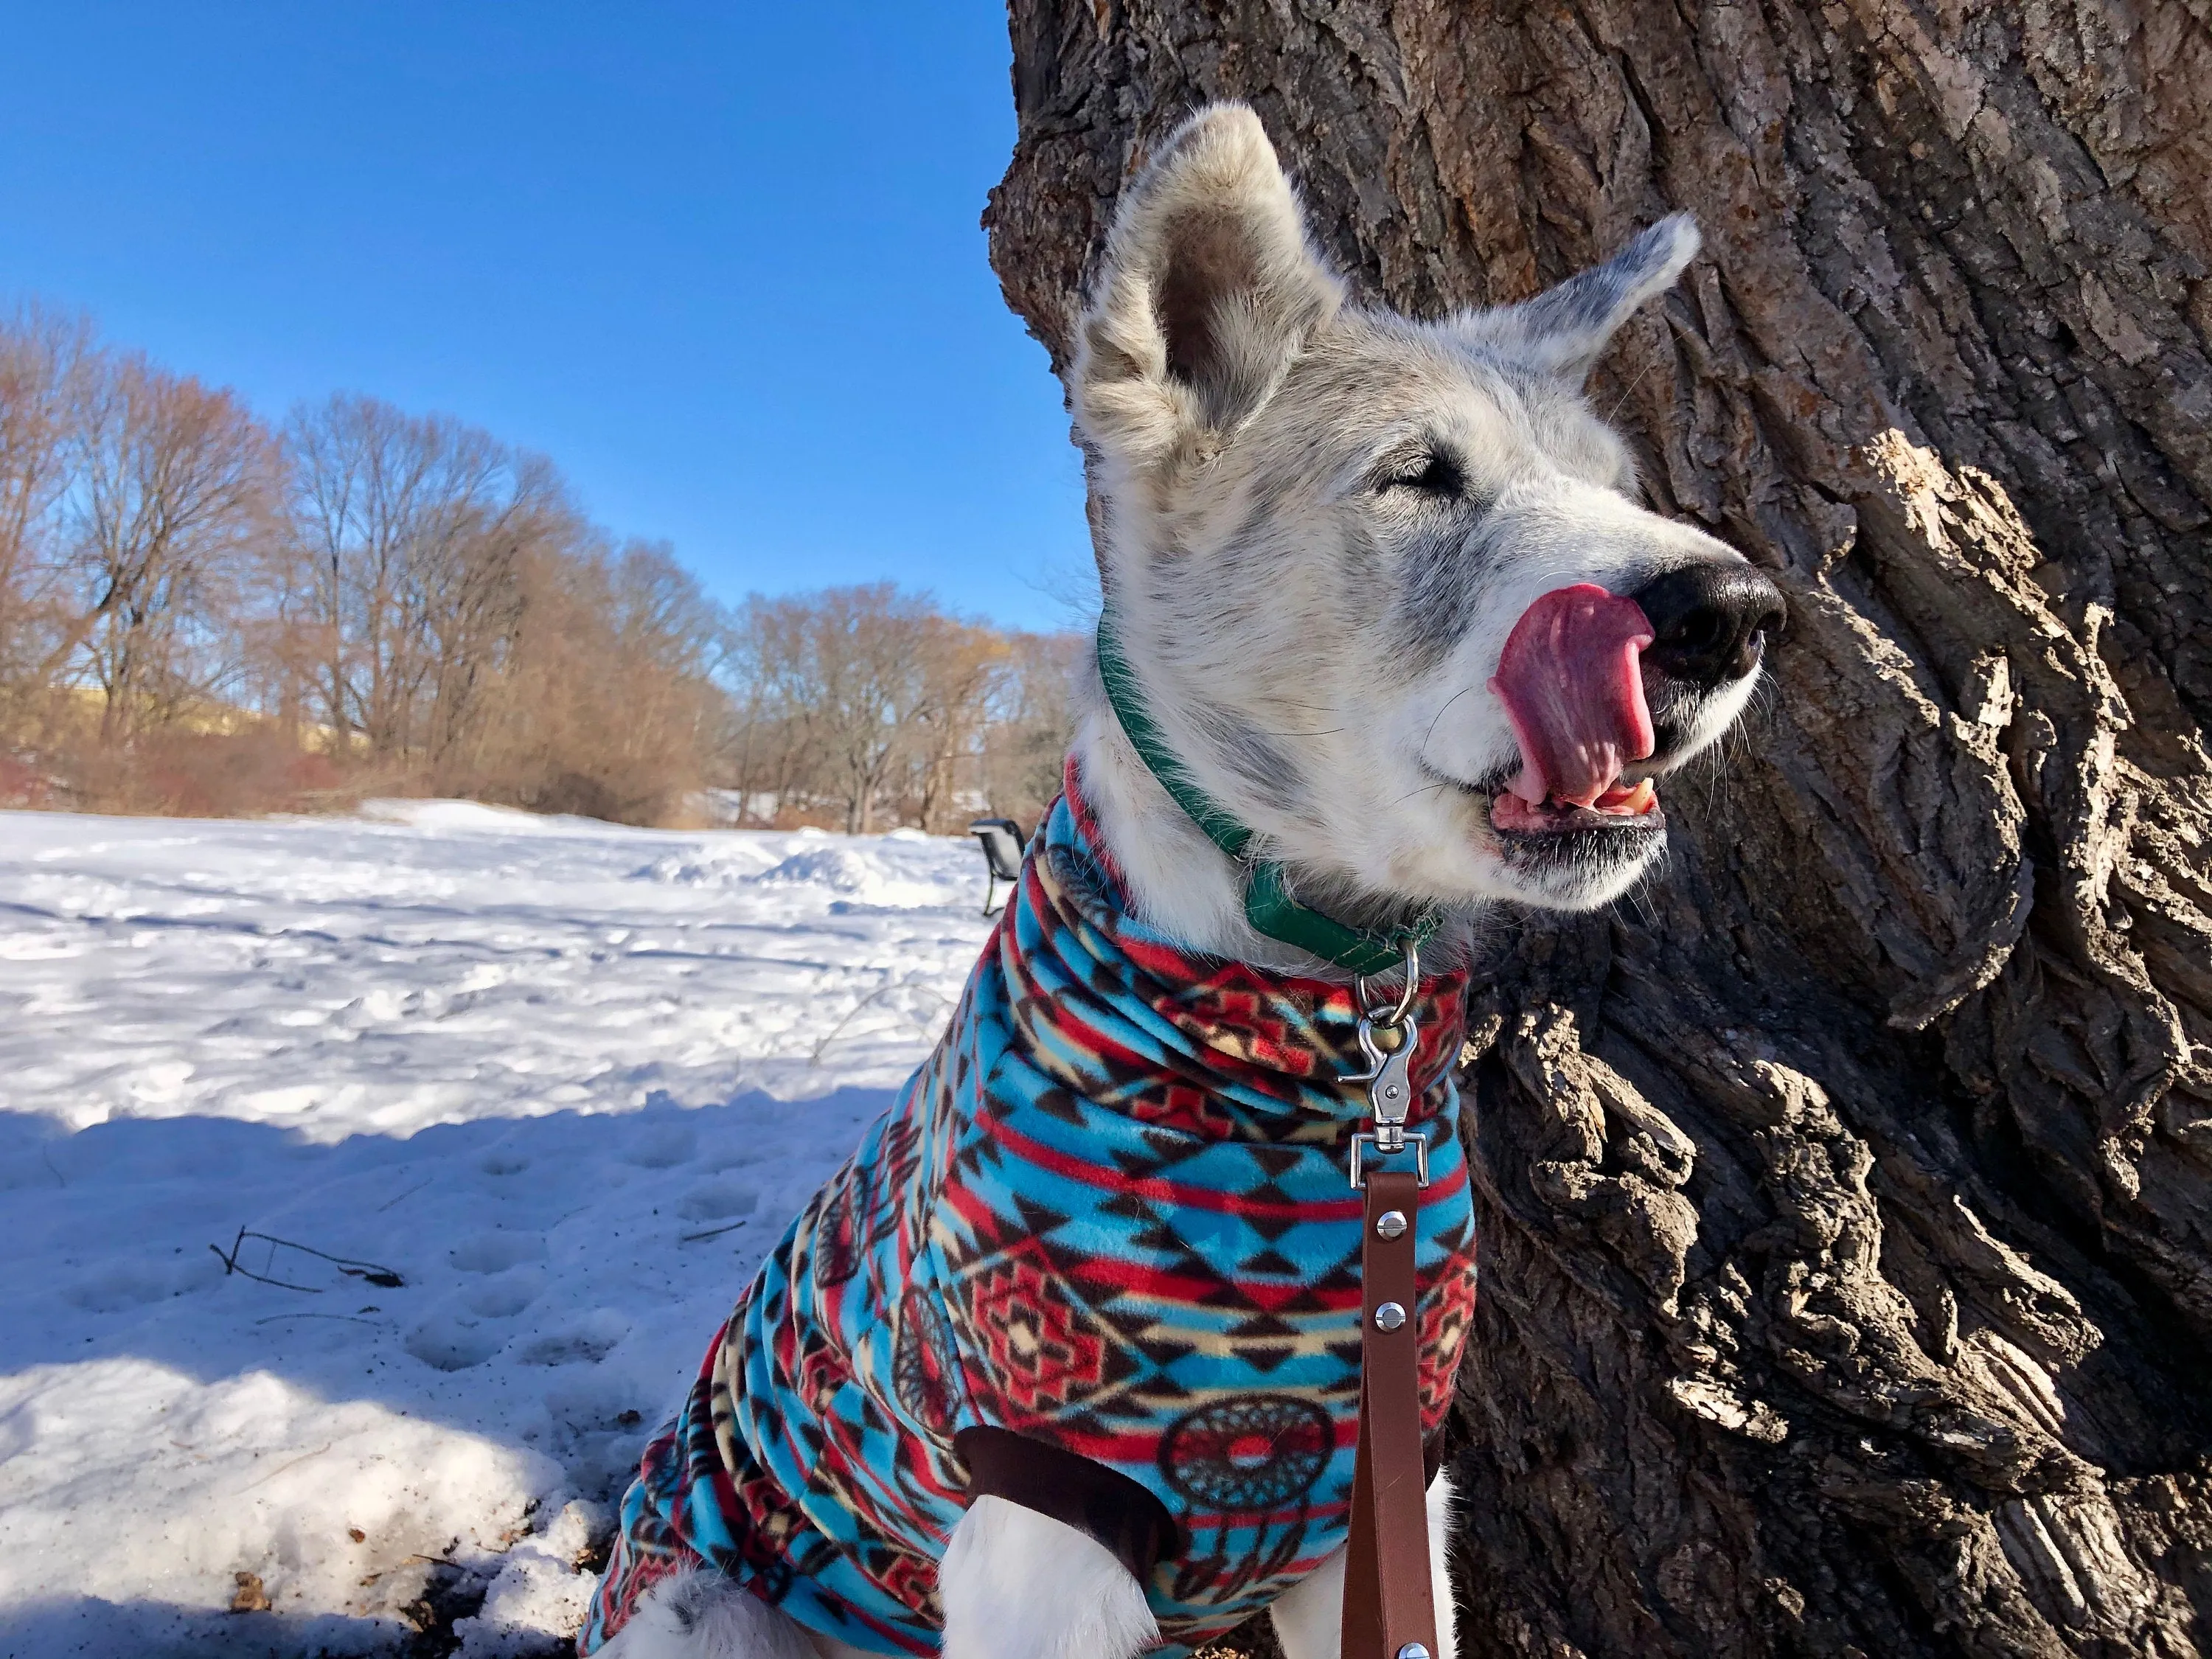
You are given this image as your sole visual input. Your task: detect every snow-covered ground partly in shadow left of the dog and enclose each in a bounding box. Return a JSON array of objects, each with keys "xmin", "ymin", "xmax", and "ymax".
[{"xmin": 0, "ymin": 803, "xmax": 989, "ymax": 1659}]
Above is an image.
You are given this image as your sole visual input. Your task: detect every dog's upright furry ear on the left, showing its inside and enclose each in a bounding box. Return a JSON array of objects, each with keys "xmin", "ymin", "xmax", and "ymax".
[{"xmin": 1075, "ymin": 104, "xmax": 1343, "ymax": 467}]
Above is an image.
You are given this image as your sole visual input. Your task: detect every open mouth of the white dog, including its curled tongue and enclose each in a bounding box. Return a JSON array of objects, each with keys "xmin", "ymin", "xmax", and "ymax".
[{"xmin": 1489, "ymin": 582, "xmax": 1666, "ymax": 852}]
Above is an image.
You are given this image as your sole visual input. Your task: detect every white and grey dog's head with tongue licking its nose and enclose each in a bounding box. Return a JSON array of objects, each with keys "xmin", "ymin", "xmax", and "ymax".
[{"xmin": 1075, "ymin": 106, "xmax": 1783, "ymax": 918}]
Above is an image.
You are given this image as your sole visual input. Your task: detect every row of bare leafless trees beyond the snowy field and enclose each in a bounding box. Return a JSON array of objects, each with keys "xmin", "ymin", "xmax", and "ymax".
[{"xmin": 0, "ymin": 303, "xmax": 1071, "ymax": 832}]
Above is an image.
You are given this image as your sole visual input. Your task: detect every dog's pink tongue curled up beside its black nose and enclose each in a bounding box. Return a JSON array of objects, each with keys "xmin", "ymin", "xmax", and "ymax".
[{"xmin": 1491, "ymin": 582, "xmax": 1652, "ymax": 807}]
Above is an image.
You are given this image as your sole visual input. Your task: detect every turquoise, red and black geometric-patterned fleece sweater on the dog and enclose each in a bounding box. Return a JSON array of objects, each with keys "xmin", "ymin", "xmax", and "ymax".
[{"xmin": 580, "ymin": 761, "xmax": 1475, "ymax": 1655}]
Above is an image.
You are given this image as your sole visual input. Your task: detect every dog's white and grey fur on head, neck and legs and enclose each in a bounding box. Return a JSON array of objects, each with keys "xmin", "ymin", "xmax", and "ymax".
[{"xmin": 606, "ymin": 104, "xmax": 1756, "ymax": 1659}]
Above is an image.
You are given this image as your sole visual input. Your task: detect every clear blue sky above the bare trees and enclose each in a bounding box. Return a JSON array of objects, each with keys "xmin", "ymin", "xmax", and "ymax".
[{"xmin": 0, "ymin": 0, "xmax": 1091, "ymax": 626}]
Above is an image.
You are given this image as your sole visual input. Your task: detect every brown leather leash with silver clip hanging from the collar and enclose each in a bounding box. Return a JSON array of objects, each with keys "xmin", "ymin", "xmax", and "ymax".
[{"xmin": 1343, "ymin": 945, "xmax": 1436, "ymax": 1659}]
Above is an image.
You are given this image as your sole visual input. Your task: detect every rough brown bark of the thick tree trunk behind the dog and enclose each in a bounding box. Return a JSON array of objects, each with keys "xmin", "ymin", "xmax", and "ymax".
[{"xmin": 987, "ymin": 0, "xmax": 2212, "ymax": 1659}]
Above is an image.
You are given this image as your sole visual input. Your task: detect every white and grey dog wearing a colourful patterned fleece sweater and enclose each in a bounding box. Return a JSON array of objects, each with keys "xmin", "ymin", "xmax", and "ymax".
[{"xmin": 580, "ymin": 104, "xmax": 1783, "ymax": 1659}]
